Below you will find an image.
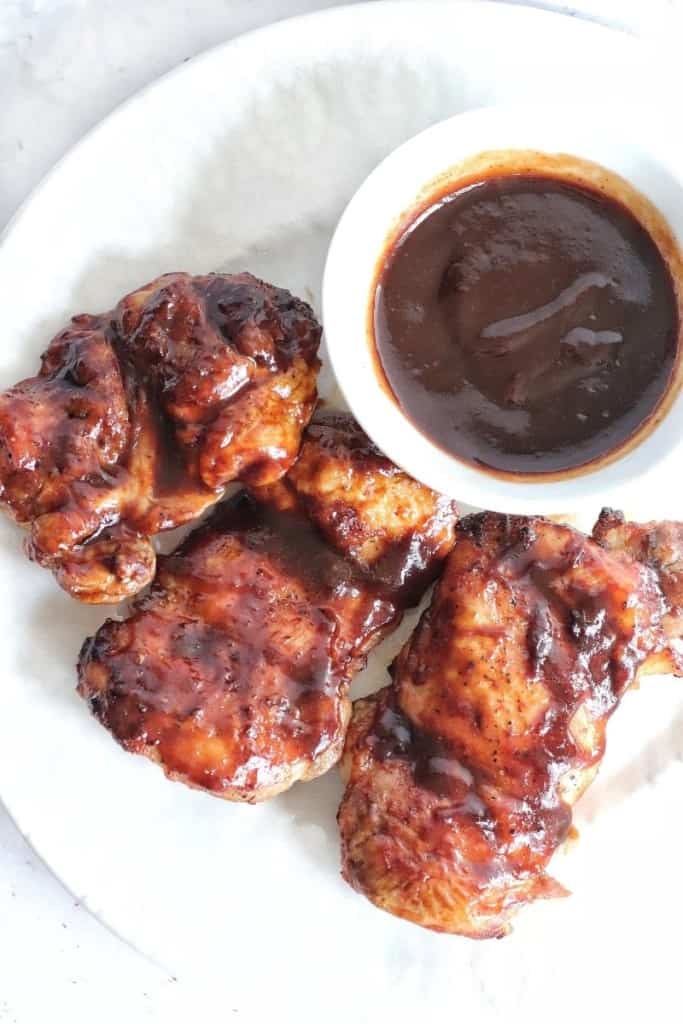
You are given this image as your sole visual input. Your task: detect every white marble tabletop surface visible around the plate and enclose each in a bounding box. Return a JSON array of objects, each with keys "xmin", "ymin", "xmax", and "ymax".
[{"xmin": 0, "ymin": 0, "xmax": 683, "ymax": 1024}]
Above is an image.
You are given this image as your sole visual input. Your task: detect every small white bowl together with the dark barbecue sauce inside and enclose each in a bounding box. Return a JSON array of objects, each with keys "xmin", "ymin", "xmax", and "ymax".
[{"xmin": 324, "ymin": 106, "xmax": 683, "ymax": 514}]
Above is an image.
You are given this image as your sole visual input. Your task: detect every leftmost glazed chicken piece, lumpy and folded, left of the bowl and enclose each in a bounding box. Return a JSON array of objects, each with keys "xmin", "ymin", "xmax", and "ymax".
[{"xmin": 0, "ymin": 273, "xmax": 321, "ymax": 603}]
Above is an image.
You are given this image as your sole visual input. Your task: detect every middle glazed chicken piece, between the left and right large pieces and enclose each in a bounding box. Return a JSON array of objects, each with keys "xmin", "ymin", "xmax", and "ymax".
[{"xmin": 79, "ymin": 414, "xmax": 456, "ymax": 802}]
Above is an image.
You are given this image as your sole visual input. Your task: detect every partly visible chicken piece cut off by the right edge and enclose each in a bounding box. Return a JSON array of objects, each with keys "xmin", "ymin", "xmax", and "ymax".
[{"xmin": 593, "ymin": 509, "xmax": 683, "ymax": 676}]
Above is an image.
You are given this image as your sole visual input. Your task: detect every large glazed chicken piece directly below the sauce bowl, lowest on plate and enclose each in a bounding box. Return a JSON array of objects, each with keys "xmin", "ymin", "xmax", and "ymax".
[{"xmin": 339, "ymin": 514, "xmax": 679, "ymax": 938}]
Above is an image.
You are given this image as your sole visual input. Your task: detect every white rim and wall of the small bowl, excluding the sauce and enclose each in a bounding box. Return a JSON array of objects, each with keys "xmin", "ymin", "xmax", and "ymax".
[{"xmin": 323, "ymin": 103, "xmax": 683, "ymax": 518}]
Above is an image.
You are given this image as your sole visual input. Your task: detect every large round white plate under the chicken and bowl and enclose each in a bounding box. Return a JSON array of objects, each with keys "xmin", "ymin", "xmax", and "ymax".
[{"xmin": 0, "ymin": 0, "xmax": 683, "ymax": 1022}]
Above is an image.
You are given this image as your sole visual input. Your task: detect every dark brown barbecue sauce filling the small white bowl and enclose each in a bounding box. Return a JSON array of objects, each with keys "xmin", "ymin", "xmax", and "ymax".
[{"xmin": 374, "ymin": 174, "xmax": 679, "ymax": 474}]
